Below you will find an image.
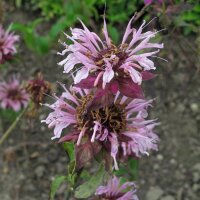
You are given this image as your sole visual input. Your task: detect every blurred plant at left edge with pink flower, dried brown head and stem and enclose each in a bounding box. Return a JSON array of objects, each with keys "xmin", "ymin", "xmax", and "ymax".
[{"xmin": 0, "ymin": 73, "xmax": 51, "ymax": 145}]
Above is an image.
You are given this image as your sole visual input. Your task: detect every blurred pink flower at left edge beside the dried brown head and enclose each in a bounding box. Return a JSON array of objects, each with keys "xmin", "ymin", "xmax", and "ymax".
[{"xmin": 0, "ymin": 77, "xmax": 29, "ymax": 112}]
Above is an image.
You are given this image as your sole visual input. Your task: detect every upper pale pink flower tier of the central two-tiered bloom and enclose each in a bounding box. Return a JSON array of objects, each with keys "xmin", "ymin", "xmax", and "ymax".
[{"xmin": 58, "ymin": 17, "xmax": 163, "ymax": 97}]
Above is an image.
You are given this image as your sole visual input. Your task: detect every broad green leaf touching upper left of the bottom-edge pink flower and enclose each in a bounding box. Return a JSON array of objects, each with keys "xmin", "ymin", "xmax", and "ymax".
[{"xmin": 75, "ymin": 165, "xmax": 105, "ymax": 199}]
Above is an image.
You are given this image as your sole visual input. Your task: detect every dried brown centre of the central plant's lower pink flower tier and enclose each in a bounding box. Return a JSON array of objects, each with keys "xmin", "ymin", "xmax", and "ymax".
[{"xmin": 77, "ymin": 95, "xmax": 126, "ymax": 133}]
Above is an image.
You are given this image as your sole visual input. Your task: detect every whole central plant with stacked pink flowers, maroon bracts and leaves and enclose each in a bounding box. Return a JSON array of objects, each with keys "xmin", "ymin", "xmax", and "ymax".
[{"xmin": 42, "ymin": 14, "xmax": 163, "ymax": 200}]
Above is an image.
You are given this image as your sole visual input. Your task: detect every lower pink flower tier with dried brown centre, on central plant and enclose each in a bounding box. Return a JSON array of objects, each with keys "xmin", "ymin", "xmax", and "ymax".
[{"xmin": 42, "ymin": 86, "xmax": 159, "ymax": 169}]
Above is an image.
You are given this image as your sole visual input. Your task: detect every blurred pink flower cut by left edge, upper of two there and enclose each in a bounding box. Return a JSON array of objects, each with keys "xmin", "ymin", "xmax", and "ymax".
[{"xmin": 0, "ymin": 25, "xmax": 19, "ymax": 64}]
